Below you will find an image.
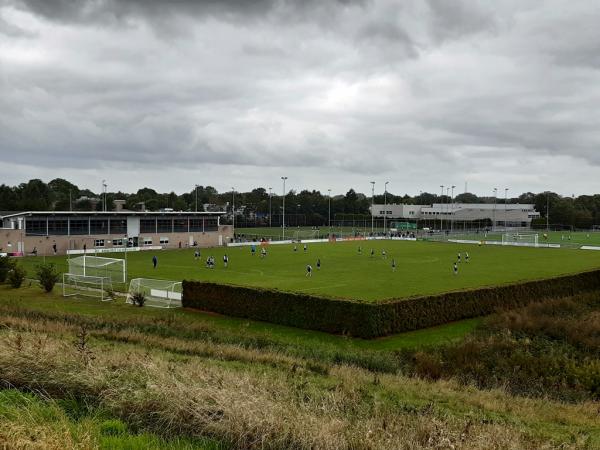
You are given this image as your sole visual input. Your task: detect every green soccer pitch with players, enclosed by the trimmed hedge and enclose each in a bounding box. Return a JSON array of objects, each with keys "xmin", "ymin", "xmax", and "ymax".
[{"xmin": 18, "ymin": 241, "xmax": 600, "ymax": 301}]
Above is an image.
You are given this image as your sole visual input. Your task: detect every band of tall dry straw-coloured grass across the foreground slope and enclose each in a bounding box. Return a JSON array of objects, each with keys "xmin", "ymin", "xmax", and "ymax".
[{"xmin": 0, "ymin": 325, "xmax": 595, "ymax": 449}]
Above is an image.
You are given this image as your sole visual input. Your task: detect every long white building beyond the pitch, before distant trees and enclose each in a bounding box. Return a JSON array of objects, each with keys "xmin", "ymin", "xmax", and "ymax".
[{"xmin": 370, "ymin": 203, "xmax": 540, "ymax": 229}]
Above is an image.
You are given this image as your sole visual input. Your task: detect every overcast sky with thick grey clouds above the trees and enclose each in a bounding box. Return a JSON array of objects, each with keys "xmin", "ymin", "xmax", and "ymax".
[{"xmin": 0, "ymin": 0, "xmax": 600, "ymax": 195}]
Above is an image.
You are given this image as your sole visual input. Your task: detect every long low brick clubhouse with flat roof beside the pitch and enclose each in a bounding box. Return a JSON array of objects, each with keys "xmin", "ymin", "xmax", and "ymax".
[{"xmin": 0, "ymin": 211, "xmax": 233, "ymax": 255}]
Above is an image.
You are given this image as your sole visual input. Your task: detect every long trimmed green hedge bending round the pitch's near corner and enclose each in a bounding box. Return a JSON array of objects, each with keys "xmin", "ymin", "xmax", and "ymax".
[{"xmin": 182, "ymin": 270, "xmax": 600, "ymax": 338}]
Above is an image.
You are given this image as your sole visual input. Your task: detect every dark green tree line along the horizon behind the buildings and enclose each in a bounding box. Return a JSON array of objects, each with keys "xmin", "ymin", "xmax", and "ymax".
[{"xmin": 0, "ymin": 178, "xmax": 600, "ymax": 229}]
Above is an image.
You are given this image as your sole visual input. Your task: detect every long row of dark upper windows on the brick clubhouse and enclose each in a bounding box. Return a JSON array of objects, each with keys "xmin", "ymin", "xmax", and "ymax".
[{"xmin": 25, "ymin": 218, "xmax": 219, "ymax": 236}]
